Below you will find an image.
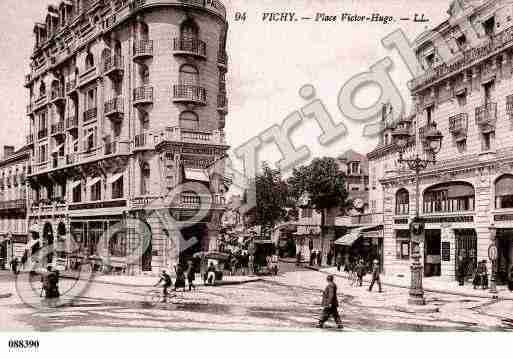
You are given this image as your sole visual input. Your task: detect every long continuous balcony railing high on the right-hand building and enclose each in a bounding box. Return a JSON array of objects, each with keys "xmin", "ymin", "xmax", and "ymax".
[{"xmin": 410, "ymin": 26, "xmax": 513, "ymax": 89}]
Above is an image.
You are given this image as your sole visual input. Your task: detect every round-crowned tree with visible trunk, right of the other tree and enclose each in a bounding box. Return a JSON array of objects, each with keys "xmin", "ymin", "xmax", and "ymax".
[{"xmin": 288, "ymin": 157, "xmax": 347, "ymax": 262}]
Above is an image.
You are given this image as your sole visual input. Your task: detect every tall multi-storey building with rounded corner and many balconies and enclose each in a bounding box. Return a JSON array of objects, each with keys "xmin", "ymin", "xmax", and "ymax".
[{"xmin": 25, "ymin": 0, "xmax": 228, "ymax": 274}]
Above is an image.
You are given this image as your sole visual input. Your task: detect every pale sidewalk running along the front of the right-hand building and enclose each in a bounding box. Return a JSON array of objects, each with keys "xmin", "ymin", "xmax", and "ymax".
[{"xmin": 307, "ymin": 266, "xmax": 513, "ymax": 300}]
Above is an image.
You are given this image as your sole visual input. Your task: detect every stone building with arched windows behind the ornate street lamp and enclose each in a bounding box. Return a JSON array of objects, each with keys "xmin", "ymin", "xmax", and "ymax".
[{"xmin": 381, "ymin": 0, "xmax": 513, "ymax": 283}]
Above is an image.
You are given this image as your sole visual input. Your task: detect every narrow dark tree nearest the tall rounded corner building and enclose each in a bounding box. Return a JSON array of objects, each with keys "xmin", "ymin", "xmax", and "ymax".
[{"xmin": 249, "ymin": 162, "xmax": 288, "ymax": 229}]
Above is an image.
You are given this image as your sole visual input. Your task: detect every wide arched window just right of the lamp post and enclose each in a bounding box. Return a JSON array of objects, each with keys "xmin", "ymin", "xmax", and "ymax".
[{"xmin": 424, "ymin": 182, "xmax": 475, "ymax": 213}]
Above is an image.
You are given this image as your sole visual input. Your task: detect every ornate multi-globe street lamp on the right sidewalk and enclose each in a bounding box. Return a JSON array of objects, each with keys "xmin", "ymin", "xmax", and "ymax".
[{"xmin": 392, "ymin": 122, "xmax": 443, "ymax": 305}]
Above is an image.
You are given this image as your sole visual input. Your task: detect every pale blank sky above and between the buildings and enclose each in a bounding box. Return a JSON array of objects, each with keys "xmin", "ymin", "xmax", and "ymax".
[{"xmin": 0, "ymin": 0, "xmax": 450, "ymax": 173}]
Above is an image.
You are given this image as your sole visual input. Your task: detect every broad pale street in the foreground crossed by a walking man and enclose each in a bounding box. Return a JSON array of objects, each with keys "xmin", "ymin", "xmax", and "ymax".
[{"xmin": 0, "ymin": 270, "xmax": 513, "ymax": 331}]
